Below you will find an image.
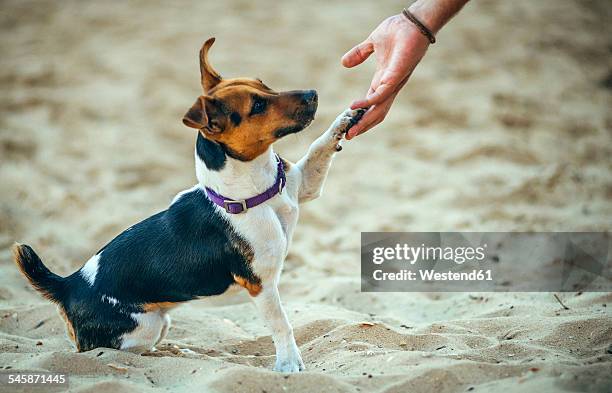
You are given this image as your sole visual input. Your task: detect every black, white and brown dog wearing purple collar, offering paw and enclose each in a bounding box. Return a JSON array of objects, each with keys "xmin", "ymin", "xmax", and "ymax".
[{"xmin": 13, "ymin": 38, "xmax": 364, "ymax": 372}]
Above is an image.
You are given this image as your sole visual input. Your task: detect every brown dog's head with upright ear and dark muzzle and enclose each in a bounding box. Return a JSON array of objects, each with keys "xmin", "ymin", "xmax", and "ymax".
[{"xmin": 183, "ymin": 38, "xmax": 317, "ymax": 161}]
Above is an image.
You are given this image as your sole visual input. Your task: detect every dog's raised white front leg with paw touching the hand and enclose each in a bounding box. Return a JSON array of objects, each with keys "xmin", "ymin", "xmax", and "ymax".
[{"xmin": 297, "ymin": 109, "xmax": 365, "ymax": 203}]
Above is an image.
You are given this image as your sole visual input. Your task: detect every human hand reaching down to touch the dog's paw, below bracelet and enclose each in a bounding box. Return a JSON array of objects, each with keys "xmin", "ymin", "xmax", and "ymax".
[{"xmin": 342, "ymin": 14, "xmax": 429, "ymax": 139}]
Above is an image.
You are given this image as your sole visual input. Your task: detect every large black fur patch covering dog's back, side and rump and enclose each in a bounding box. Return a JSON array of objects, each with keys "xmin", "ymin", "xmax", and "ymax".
[{"xmin": 59, "ymin": 189, "xmax": 259, "ymax": 351}]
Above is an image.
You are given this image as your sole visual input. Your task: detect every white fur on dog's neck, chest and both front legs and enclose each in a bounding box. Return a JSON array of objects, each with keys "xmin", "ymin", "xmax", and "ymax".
[{"xmin": 195, "ymin": 111, "xmax": 355, "ymax": 372}]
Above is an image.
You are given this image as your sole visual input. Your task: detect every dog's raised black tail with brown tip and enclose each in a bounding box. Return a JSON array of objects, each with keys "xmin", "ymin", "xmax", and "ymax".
[{"xmin": 13, "ymin": 243, "xmax": 66, "ymax": 303}]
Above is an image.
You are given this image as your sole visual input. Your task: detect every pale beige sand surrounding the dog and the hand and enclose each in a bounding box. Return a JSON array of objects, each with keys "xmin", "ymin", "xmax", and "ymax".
[{"xmin": 0, "ymin": 0, "xmax": 612, "ymax": 393}]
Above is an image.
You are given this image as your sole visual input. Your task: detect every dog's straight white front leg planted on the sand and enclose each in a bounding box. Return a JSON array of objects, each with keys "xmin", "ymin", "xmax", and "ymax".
[{"xmin": 253, "ymin": 284, "xmax": 304, "ymax": 373}]
